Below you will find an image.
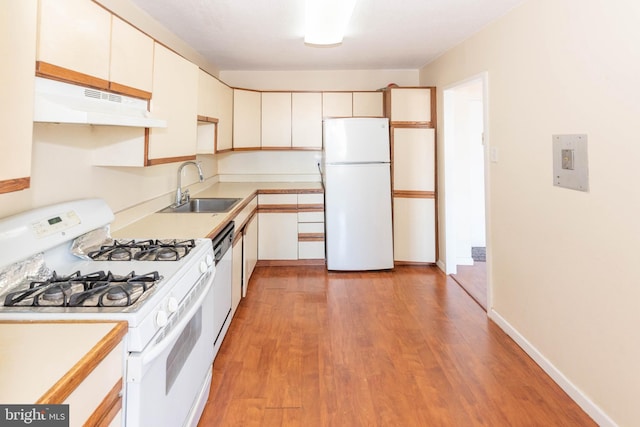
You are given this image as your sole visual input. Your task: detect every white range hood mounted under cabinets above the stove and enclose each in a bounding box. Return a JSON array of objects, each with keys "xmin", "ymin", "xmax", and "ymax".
[{"xmin": 33, "ymin": 77, "xmax": 167, "ymax": 128}]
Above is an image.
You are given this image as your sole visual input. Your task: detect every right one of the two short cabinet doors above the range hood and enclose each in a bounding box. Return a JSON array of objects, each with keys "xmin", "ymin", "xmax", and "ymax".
[{"xmin": 109, "ymin": 16, "xmax": 153, "ymax": 92}]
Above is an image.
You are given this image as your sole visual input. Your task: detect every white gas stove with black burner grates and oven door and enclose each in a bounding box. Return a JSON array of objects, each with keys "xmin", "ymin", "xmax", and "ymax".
[{"xmin": 0, "ymin": 199, "xmax": 217, "ymax": 426}]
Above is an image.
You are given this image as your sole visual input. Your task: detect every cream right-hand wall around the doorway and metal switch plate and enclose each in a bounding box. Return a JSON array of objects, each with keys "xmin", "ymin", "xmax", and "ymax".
[{"xmin": 420, "ymin": 0, "xmax": 640, "ymax": 426}]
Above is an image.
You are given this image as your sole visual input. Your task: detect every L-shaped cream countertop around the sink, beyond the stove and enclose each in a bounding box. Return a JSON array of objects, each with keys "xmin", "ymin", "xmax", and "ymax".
[{"xmin": 112, "ymin": 182, "xmax": 322, "ymax": 239}]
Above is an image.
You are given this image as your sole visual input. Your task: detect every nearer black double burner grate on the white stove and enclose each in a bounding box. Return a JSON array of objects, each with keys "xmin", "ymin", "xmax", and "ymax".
[{"xmin": 4, "ymin": 271, "xmax": 162, "ymax": 307}]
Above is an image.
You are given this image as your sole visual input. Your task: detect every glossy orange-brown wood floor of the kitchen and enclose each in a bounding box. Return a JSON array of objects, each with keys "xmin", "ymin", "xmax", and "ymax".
[{"xmin": 199, "ymin": 267, "xmax": 595, "ymax": 427}]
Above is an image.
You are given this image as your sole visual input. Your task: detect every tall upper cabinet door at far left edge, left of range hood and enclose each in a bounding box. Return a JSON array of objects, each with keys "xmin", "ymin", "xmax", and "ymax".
[{"xmin": 0, "ymin": 0, "xmax": 37, "ymax": 193}]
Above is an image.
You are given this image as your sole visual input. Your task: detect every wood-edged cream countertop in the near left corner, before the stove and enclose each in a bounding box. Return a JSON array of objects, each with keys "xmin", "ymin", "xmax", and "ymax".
[{"xmin": 0, "ymin": 321, "xmax": 127, "ymax": 405}]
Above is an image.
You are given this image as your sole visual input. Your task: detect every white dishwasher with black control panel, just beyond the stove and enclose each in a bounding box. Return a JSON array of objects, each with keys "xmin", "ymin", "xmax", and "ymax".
[{"xmin": 212, "ymin": 221, "xmax": 235, "ymax": 359}]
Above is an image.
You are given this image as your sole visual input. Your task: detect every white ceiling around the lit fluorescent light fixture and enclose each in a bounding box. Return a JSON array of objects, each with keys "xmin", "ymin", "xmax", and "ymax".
[{"xmin": 132, "ymin": 0, "xmax": 523, "ymax": 70}]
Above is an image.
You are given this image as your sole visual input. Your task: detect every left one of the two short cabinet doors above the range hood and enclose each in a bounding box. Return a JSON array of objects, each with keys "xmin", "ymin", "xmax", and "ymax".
[{"xmin": 37, "ymin": 0, "xmax": 111, "ymax": 82}]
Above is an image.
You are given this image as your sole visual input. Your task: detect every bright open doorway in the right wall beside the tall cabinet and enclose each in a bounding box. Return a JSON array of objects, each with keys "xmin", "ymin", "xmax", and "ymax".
[{"xmin": 444, "ymin": 73, "xmax": 491, "ymax": 311}]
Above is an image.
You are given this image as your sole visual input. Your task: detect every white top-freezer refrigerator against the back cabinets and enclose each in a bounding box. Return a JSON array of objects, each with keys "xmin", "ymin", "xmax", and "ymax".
[{"xmin": 322, "ymin": 117, "xmax": 393, "ymax": 271}]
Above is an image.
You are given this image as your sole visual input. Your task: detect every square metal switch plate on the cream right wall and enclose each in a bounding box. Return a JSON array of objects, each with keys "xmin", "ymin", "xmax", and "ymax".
[{"xmin": 552, "ymin": 134, "xmax": 589, "ymax": 191}]
